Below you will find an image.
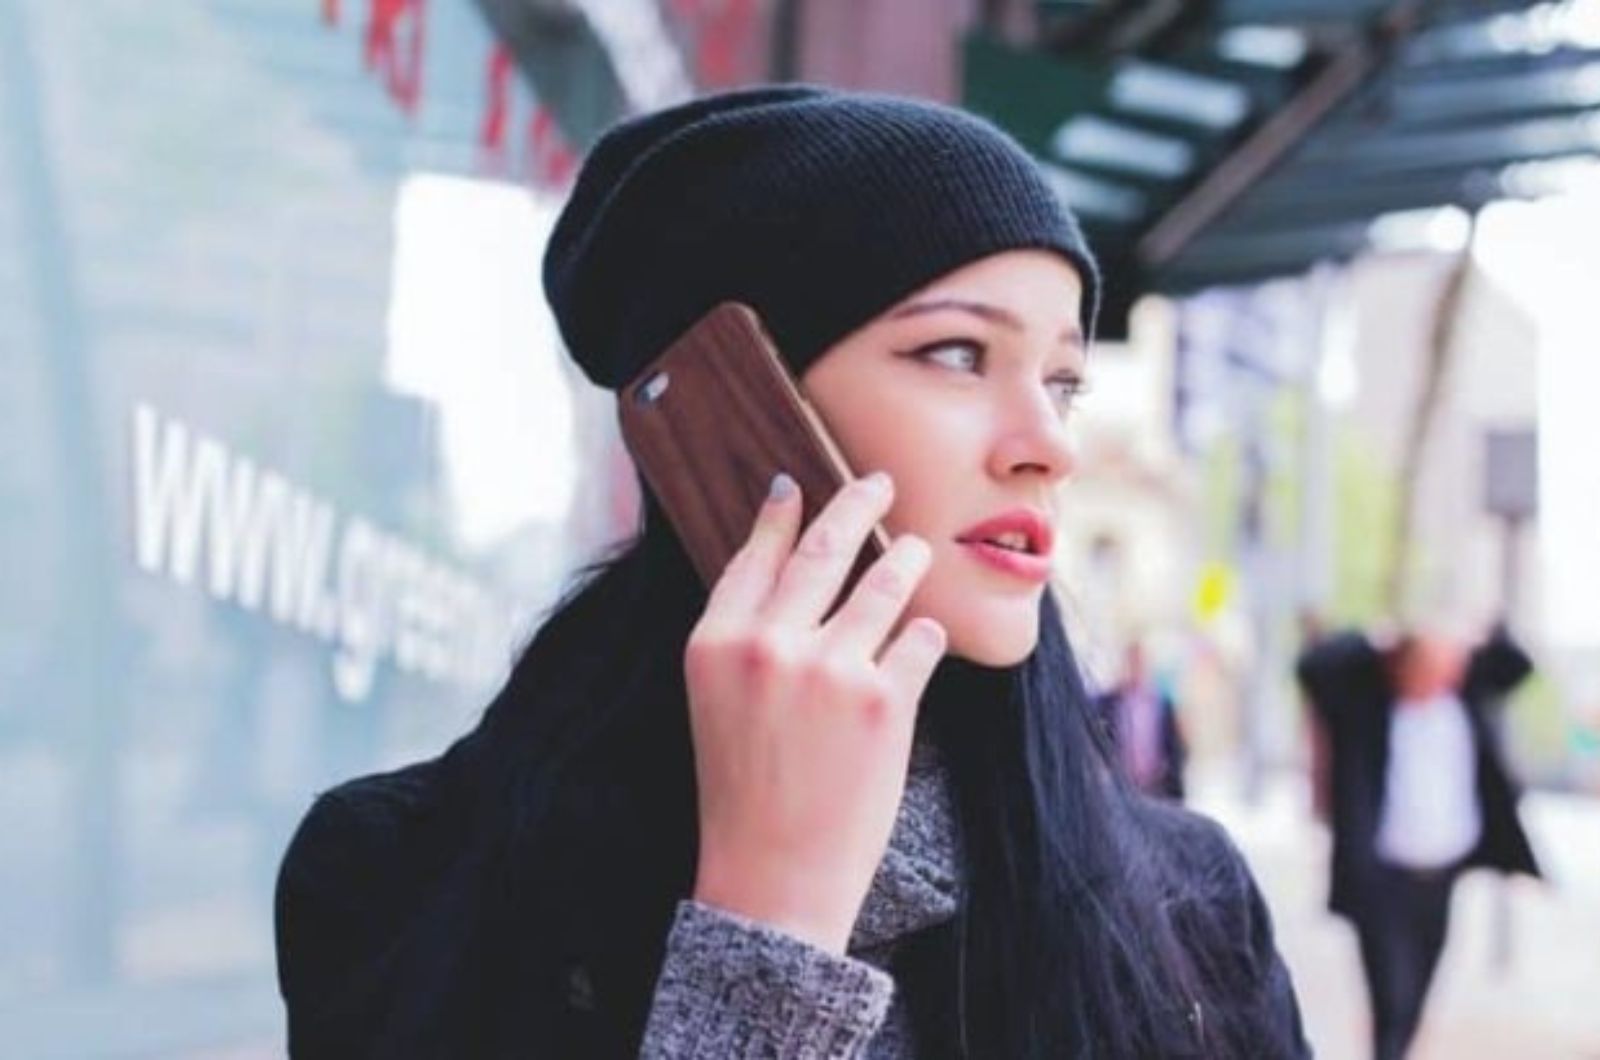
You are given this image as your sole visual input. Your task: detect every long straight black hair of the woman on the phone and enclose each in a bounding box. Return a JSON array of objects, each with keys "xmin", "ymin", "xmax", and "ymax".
[{"xmin": 457, "ymin": 495, "xmax": 1232, "ymax": 1060}]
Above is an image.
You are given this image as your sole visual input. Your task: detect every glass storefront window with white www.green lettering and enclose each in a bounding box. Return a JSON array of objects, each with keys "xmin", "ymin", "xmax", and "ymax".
[{"xmin": 0, "ymin": 0, "xmax": 634, "ymax": 1058}]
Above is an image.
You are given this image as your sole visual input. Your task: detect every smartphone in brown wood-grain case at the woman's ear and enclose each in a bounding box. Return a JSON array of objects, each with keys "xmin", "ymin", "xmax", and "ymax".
[{"xmin": 618, "ymin": 303, "xmax": 888, "ymax": 597}]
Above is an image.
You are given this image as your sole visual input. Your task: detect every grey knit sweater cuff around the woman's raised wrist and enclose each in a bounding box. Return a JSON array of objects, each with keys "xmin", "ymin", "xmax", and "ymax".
[{"xmin": 640, "ymin": 901, "xmax": 894, "ymax": 1060}]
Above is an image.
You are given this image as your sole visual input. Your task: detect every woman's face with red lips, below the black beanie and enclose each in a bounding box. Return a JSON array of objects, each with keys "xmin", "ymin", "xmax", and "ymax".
[{"xmin": 800, "ymin": 250, "xmax": 1085, "ymax": 666}]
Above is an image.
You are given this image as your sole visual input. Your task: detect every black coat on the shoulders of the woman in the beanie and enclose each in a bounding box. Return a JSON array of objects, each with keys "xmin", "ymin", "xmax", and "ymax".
[{"xmin": 277, "ymin": 745, "xmax": 1309, "ymax": 1060}]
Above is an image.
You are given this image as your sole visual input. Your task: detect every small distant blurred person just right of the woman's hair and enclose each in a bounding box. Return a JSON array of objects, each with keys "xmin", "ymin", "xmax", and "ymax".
[{"xmin": 1099, "ymin": 637, "xmax": 1187, "ymax": 802}]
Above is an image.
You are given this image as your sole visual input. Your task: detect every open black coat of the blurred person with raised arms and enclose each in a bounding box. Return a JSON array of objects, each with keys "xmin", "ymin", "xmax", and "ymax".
[{"xmin": 1296, "ymin": 631, "xmax": 1539, "ymax": 919}]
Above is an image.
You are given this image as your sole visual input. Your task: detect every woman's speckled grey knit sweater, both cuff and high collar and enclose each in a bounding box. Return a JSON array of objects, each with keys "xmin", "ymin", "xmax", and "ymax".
[{"xmin": 640, "ymin": 745, "xmax": 960, "ymax": 1060}]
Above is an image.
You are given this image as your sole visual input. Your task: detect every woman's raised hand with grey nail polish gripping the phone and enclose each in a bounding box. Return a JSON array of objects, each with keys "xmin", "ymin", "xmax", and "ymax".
[{"xmin": 685, "ymin": 474, "xmax": 946, "ymax": 953}]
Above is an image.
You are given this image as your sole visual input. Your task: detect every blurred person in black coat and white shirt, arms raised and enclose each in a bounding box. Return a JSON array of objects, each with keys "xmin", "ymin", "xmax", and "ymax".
[{"xmin": 1298, "ymin": 624, "xmax": 1538, "ymax": 1060}]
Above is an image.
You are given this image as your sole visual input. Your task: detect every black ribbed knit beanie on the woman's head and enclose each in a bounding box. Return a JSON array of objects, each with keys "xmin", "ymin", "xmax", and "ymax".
[{"xmin": 544, "ymin": 85, "xmax": 1099, "ymax": 389}]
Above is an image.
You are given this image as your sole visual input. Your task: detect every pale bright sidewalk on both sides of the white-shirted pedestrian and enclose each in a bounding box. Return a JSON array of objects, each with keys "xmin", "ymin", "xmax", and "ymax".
[{"xmin": 1190, "ymin": 775, "xmax": 1600, "ymax": 1060}]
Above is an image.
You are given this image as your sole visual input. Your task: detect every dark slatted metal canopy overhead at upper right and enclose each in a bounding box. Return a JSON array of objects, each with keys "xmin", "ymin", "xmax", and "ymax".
[{"xmin": 965, "ymin": 0, "xmax": 1600, "ymax": 335}]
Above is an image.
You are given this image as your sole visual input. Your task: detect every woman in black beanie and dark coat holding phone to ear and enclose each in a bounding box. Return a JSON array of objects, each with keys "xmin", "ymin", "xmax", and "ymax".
[{"xmin": 278, "ymin": 86, "xmax": 1307, "ymax": 1060}]
